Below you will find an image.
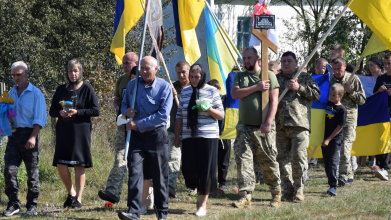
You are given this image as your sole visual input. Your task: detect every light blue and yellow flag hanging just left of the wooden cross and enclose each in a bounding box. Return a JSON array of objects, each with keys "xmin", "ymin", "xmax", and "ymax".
[{"xmin": 204, "ymin": 6, "xmax": 240, "ymax": 94}]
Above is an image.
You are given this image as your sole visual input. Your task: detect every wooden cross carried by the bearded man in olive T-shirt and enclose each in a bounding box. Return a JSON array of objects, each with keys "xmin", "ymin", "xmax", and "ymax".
[{"xmin": 251, "ymin": 27, "xmax": 278, "ymax": 123}]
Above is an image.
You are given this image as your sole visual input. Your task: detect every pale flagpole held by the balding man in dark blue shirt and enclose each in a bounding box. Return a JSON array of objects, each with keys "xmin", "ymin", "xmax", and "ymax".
[{"xmin": 123, "ymin": 0, "xmax": 149, "ymax": 160}]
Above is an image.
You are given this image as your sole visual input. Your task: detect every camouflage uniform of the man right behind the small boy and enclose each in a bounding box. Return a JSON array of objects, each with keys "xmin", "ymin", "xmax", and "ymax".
[{"xmin": 330, "ymin": 72, "xmax": 366, "ymax": 180}]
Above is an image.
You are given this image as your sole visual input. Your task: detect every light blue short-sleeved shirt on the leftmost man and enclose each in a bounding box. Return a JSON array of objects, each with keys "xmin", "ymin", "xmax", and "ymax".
[{"xmin": 9, "ymin": 82, "xmax": 47, "ymax": 128}]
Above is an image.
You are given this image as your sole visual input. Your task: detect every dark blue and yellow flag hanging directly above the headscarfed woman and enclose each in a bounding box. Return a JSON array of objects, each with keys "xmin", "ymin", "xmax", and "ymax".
[{"xmin": 172, "ymin": 0, "xmax": 205, "ymax": 65}]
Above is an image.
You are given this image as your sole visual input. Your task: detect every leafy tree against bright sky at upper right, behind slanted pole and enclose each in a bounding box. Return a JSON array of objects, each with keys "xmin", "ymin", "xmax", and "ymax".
[{"xmin": 272, "ymin": 0, "xmax": 371, "ymax": 69}]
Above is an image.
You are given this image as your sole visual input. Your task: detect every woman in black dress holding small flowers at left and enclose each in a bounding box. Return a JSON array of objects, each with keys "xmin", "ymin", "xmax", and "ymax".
[{"xmin": 49, "ymin": 59, "xmax": 99, "ymax": 208}]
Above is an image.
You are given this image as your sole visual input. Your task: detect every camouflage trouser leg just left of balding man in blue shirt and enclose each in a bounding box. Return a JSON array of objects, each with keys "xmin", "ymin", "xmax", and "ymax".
[{"xmin": 105, "ymin": 125, "xmax": 128, "ymax": 198}]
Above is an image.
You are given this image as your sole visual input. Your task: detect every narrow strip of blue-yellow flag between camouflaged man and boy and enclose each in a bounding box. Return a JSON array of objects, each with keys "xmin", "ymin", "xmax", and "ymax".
[{"xmin": 307, "ymin": 73, "xmax": 330, "ymax": 158}]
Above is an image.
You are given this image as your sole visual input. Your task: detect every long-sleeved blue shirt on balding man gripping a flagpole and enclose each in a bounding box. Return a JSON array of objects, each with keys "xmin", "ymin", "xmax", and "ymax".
[{"xmin": 121, "ymin": 77, "xmax": 173, "ymax": 133}]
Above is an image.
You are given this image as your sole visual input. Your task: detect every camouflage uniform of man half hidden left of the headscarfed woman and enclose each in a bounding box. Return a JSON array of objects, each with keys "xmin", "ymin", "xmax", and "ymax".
[{"xmin": 167, "ymin": 81, "xmax": 188, "ymax": 189}]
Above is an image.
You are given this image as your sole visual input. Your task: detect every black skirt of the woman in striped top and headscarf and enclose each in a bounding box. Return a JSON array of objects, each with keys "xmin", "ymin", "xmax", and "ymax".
[{"xmin": 182, "ymin": 138, "xmax": 218, "ymax": 195}]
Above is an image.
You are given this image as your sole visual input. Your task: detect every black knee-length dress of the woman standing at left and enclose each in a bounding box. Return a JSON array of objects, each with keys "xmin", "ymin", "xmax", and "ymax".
[{"xmin": 49, "ymin": 83, "xmax": 99, "ymax": 168}]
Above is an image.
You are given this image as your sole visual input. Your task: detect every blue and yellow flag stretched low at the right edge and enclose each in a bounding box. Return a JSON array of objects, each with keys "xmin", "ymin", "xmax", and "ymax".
[{"xmin": 351, "ymin": 91, "xmax": 391, "ymax": 156}]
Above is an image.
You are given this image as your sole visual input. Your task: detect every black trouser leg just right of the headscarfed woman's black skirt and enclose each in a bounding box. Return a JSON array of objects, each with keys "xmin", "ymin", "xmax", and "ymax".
[{"xmin": 217, "ymin": 139, "xmax": 231, "ymax": 185}]
